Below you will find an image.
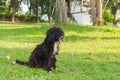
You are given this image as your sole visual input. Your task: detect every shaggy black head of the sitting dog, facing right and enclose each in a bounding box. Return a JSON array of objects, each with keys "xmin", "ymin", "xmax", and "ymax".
[{"xmin": 46, "ymin": 27, "xmax": 64, "ymax": 42}]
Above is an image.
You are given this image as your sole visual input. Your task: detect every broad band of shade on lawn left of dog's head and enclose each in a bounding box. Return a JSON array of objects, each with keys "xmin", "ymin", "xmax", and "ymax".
[{"xmin": 0, "ymin": 25, "xmax": 53, "ymax": 42}]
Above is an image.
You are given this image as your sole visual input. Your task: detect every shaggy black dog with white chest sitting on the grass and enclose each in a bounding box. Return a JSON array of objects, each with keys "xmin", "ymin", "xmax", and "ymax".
[{"xmin": 15, "ymin": 27, "xmax": 64, "ymax": 71}]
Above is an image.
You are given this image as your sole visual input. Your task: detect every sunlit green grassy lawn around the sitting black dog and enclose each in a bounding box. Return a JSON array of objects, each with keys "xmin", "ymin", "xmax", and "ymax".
[{"xmin": 0, "ymin": 24, "xmax": 120, "ymax": 80}]
